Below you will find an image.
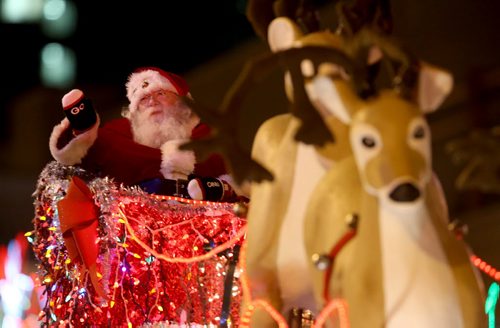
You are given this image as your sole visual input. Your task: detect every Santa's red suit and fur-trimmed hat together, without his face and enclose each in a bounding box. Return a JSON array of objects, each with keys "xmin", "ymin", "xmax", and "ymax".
[{"xmin": 49, "ymin": 67, "xmax": 242, "ymax": 199}]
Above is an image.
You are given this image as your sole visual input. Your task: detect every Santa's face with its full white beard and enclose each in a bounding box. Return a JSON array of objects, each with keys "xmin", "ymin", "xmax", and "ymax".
[{"xmin": 129, "ymin": 90, "xmax": 199, "ymax": 148}]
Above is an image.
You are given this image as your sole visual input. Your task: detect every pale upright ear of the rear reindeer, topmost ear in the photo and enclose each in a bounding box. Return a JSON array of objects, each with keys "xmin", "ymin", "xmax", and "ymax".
[{"xmin": 267, "ymin": 17, "xmax": 303, "ymax": 52}]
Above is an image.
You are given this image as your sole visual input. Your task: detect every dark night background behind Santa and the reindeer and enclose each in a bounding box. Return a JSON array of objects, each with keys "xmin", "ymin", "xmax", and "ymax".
[{"xmin": 0, "ymin": 0, "xmax": 500, "ymax": 288}]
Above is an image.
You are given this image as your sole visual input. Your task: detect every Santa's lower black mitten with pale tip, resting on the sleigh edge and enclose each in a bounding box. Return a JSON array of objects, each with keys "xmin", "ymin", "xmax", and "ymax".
[{"xmin": 187, "ymin": 177, "xmax": 238, "ymax": 202}]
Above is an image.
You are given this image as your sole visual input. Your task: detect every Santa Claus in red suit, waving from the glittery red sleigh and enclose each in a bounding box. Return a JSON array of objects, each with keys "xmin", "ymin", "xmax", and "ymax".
[{"xmin": 49, "ymin": 67, "xmax": 240, "ymax": 200}]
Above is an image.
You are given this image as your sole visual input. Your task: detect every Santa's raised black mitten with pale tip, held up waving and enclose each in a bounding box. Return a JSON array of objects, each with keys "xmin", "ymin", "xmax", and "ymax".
[{"xmin": 62, "ymin": 89, "xmax": 97, "ymax": 134}]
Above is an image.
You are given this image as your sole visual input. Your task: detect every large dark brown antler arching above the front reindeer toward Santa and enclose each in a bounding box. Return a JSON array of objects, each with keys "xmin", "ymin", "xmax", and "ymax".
[{"xmin": 183, "ymin": 0, "xmax": 416, "ymax": 183}]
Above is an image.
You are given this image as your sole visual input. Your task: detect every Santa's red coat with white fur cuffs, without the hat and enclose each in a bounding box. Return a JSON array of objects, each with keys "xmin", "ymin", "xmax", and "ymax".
[{"xmin": 49, "ymin": 118, "xmax": 227, "ymax": 185}]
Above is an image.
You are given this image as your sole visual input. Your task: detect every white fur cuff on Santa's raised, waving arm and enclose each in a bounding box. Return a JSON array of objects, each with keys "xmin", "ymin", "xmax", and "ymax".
[{"xmin": 49, "ymin": 116, "xmax": 100, "ymax": 165}]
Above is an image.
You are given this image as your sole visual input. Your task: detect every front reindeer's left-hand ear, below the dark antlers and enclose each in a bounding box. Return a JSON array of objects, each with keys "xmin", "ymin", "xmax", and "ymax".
[{"xmin": 307, "ymin": 75, "xmax": 361, "ymax": 124}]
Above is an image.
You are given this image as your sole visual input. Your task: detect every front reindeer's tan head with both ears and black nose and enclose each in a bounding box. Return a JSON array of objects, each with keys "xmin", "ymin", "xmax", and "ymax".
[{"xmin": 308, "ymin": 65, "xmax": 451, "ymax": 204}]
